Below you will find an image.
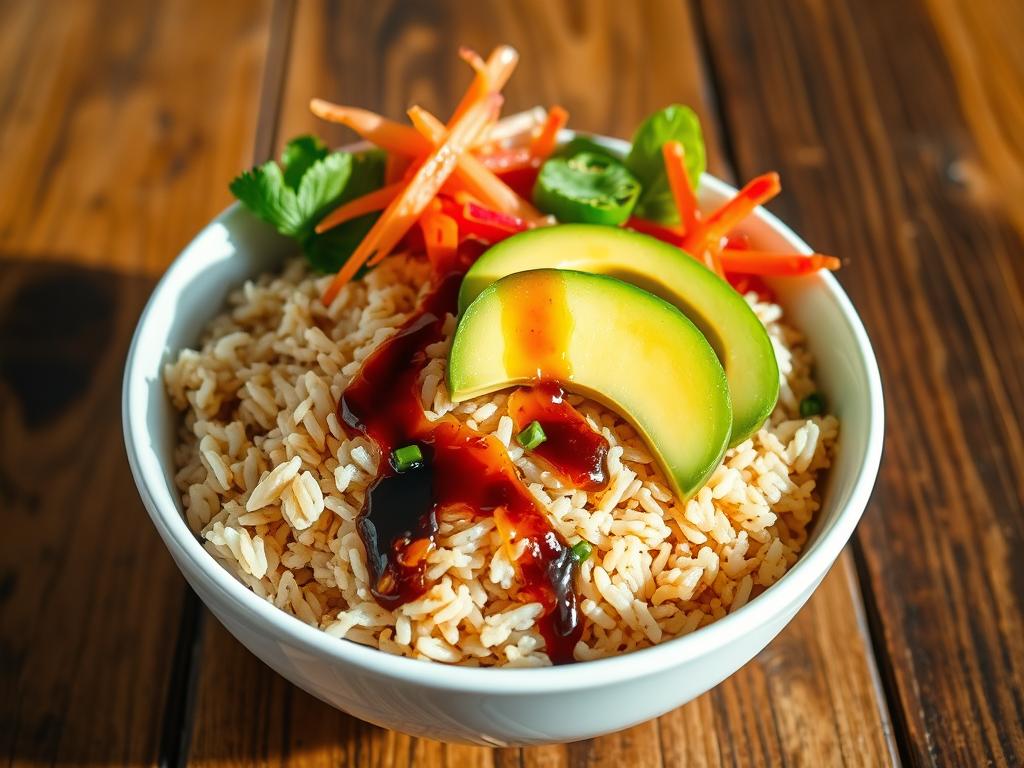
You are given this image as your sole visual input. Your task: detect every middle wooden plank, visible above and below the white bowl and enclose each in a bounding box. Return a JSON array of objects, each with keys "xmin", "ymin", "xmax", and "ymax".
[{"xmin": 190, "ymin": 2, "xmax": 892, "ymax": 768}]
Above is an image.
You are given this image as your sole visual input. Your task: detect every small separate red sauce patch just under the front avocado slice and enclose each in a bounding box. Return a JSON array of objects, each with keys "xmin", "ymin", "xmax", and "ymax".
[{"xmin": 509, "ymin": 381, "xmax": 608, "ymax": 490}]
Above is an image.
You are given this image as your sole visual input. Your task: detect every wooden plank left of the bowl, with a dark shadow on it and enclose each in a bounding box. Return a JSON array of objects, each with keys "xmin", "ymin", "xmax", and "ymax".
[{"xmin": 0, "ymin": 1, "xmax": 268, "ymax": 765}]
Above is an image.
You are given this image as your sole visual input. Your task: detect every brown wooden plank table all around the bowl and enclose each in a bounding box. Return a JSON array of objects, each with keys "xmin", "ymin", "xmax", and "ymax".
[{"xmin": 0, "ymin": 0, "xmax": 1024, "ymax": 767}]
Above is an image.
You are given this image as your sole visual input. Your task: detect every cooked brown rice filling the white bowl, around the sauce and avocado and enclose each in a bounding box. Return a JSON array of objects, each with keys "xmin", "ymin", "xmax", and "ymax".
[{"xmin": 165, "ymin": 258, "xmax": 839, "ymax": 667}]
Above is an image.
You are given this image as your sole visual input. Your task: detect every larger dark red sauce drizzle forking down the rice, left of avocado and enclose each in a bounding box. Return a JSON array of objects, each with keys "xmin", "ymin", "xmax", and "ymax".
[{"xmin": 338, "ymin": 272, "xmax": 583, "ymax": 664}]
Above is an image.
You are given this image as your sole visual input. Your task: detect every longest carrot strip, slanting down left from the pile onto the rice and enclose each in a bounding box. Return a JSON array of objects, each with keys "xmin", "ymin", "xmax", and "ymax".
[{"xmin": 323, "ymin": 95, "xmax": 501, "ymax": 304}]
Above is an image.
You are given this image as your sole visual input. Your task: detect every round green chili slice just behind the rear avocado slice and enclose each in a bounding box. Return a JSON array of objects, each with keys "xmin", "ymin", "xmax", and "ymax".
[{"xmin": 534, "ymin": 152, "xmax": 640, "ymax": 226}]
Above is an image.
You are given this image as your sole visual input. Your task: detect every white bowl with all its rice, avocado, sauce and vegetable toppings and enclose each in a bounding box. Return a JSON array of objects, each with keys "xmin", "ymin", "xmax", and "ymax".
[{"xmin": 124, "ymin": 46, "xmax": 882, "ymax": 744}]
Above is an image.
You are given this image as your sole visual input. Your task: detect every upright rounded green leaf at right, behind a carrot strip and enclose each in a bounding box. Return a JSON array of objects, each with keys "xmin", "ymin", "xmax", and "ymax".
[{"xmin": 626, "ymin": 104, "xmax": 708, "ymax": 224}]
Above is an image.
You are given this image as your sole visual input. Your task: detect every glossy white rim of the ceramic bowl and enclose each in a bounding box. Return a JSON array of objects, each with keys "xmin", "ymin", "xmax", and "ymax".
[{"xmin": 122, "ymin": 131, "xmax": 885, "ymax": 695}]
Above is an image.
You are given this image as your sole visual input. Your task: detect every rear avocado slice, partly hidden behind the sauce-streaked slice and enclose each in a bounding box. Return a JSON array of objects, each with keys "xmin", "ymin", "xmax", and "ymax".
[{"xmin": 459, "ymin": 224, "xmax": 778, "ymax": 445}]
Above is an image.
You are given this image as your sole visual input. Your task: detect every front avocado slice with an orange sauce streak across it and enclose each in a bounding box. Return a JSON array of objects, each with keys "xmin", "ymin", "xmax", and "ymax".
[{"xmin": 447, "ymin": 269, "xmax": 732, "ymax": 499}]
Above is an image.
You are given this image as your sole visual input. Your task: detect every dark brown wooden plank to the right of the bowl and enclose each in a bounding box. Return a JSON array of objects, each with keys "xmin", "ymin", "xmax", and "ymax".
[{"xmin": 705, "ymin": 0, "xmax": 1024, "ymax": 765}]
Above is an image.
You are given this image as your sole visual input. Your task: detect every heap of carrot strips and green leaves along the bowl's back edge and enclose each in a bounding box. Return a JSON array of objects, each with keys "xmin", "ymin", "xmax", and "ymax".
[{"xmin": 231, "ymin": 46, "xmax": 840, "ymax": 303}]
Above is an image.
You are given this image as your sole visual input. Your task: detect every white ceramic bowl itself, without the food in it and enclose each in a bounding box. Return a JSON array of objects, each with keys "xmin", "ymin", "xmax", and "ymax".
[{"xmin": 123, "ymin": 135, "xmax": 883, "ymax": 745}]
